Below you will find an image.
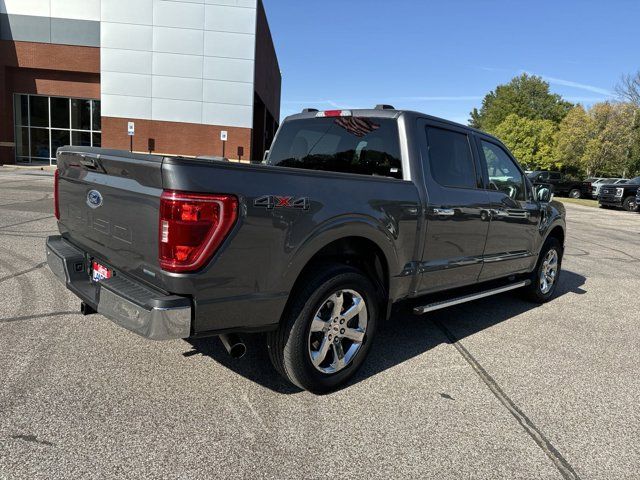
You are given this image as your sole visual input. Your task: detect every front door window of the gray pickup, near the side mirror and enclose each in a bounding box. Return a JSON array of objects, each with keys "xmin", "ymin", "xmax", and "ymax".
[{"xmin": 482, "ymin": 140, "xmax": 527, "ymax": 200}]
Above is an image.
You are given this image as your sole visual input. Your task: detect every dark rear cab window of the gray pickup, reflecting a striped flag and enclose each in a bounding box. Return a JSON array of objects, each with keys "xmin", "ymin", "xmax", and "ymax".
[{"xmin": 269, "ymin": 117, "xmax": 402, "ymax": 179}]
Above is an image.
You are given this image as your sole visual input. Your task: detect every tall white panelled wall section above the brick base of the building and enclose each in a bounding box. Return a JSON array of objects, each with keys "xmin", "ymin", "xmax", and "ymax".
[{"xmin": 101, "ymin": 0, "xmax": 257, "ymax": 128}]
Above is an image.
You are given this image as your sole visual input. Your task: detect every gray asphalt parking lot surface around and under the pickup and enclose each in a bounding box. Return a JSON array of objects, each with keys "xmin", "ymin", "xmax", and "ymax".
[{"xmin": 0, "ymin": 172, "xmax": 640, "ymax": 479}]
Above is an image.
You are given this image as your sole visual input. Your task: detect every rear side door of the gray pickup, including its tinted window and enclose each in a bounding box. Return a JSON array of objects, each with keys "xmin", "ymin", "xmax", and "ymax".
[{"xmin": 417, "ymin": 120, "xmax": 490, "ymax": 294}]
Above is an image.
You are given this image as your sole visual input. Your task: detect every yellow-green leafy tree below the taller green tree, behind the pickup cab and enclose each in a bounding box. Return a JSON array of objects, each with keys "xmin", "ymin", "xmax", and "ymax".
[{"xmin": 494, "ymin": 114, "xmax": 562, "ymax": 170}]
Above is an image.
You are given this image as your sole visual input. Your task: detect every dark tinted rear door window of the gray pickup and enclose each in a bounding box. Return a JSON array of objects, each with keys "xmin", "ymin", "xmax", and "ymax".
[{"xmin": 427, "ymin": 127, "xmax": 477, "ymax": 188}]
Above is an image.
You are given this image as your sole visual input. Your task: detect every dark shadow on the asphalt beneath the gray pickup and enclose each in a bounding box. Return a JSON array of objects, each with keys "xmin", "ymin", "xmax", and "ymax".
[{"xmin": 184, "ymin": 270, "xmax": 586, "ymax": 394}]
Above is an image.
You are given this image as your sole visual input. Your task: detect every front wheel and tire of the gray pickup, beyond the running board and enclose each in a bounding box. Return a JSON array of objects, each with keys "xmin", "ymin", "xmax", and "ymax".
[{"xmin": 523, "ymin": 237, "xmax": 564, "ymax": 303}]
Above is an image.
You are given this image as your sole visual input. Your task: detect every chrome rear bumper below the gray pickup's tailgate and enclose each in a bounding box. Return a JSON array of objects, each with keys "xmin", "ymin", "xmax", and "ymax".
[{"xmin": 47, "ymin": 236, "xmax": 192, "ymax": 340}]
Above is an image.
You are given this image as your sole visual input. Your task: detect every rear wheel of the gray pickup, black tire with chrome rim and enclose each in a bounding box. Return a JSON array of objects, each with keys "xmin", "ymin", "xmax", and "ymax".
[{"xmin": 267, "ymin": 265, "xmax": 380, "ymax": 394}]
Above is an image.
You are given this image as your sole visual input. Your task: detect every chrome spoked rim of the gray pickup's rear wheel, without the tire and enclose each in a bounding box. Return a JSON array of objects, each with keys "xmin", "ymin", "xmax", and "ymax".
[{"xmin": 308, "ymin": 290, "xmax": 368, "ymax": 374}]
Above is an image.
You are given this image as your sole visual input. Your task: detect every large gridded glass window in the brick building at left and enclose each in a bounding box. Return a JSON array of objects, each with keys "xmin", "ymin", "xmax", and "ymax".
[{"xmin": 14, "ymin": 94, "xmax": 102, "ymax": 165}]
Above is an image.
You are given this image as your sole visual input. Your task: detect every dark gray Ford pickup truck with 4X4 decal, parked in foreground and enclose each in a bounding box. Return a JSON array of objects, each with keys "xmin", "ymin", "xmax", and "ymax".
[{"xmin": 46, "ymin": 106, "xmax": 565, "ymax": 393}]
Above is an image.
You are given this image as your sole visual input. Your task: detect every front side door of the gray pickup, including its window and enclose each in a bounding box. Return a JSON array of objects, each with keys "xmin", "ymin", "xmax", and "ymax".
[{"xmin": 477, "ymin": 137, "xmax": 541, "ymax": 281}]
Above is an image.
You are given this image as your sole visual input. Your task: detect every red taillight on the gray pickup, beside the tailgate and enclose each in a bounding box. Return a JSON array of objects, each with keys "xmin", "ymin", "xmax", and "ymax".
[{"xmin": 158, "ymin": 191, "xmax": 238, "ymax": 272}]
